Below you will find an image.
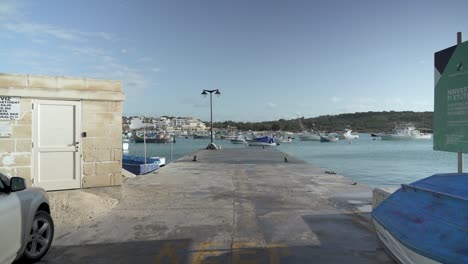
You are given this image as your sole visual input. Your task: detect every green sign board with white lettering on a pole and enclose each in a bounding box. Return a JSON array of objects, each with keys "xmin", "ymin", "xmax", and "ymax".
[{"xmin": 434, "ymin": 42, "xmax": 468, "ymax": 153}]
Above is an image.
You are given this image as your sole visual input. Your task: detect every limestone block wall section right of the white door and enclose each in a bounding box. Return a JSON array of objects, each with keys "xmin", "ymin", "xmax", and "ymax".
[{"xmin": 81, "ymin": 101, "xmax": 122, "ymax": 188}]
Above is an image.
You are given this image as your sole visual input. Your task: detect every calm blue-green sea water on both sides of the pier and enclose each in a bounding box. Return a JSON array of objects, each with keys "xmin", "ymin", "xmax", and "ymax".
[{"xmin": 124, "ymin": 134, "xmax": 468, "ymax": 187}]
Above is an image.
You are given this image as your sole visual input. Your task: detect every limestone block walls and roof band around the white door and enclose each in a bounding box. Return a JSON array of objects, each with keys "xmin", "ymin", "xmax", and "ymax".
[{"xmin": 0, "ymin": 73, "xmax": 125, "ymax": 188}]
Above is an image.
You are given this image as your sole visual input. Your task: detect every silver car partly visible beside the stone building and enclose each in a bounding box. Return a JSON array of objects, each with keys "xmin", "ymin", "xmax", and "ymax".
[{"xmin": 0, "ymin": 173, "xmax": 54, "ymax": 264}]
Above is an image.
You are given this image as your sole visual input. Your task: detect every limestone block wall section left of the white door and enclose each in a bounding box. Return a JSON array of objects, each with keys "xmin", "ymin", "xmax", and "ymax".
[{"xmin": 0, "ymin": 98, "xmax": 32, "ymax": 186}]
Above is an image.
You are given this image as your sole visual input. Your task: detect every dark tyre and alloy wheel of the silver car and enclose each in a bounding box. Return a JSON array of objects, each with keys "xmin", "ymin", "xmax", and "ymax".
[{"xmin": 23, "ymin": 211, "xmax": 54, "ymax": 262}]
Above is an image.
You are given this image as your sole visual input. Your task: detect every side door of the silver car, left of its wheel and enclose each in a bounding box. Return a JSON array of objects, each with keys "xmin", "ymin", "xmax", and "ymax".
[{"xmin": 0, "ymin": 177, "xmax": 21, "ymax": 264}]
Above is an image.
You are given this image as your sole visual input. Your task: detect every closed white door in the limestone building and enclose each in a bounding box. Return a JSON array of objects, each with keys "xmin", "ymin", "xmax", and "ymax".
[{"xmin": 33, "ymin": 100, "xmax": 81, "ymax": 190}]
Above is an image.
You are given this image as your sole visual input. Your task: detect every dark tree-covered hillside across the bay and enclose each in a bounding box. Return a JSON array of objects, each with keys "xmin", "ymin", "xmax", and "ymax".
[{"xmin": 213, "ymin": 111, "xmax": 433, "ymax": 132}]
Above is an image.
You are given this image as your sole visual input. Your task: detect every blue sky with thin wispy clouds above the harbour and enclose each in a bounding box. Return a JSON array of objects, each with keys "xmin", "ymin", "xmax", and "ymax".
[{"xmin": 0, "ymin": 0, "xmax": 468, "ymax": 121}]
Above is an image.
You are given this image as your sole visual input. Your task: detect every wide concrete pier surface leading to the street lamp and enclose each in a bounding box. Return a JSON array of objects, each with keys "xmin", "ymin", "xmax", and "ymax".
[{"xmin": 41, "ymin": 148, "xmax": 393, "ymax": 264}]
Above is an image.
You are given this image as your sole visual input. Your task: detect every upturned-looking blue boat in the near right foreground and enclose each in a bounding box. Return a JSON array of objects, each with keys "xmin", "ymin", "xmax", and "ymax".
[{"xmin": 372, "ymin": 173, "xmax": 468, "ymax": 264}]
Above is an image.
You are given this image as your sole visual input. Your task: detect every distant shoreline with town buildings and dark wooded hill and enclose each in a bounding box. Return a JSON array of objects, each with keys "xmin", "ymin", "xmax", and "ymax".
[{"xmin": 122, "ymin": 111, "xmax": 433, "ymax": 135}]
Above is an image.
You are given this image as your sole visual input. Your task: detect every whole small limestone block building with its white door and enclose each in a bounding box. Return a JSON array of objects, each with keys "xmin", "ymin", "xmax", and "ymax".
[{"xmin": 0, "ymin": 74, "xmax": 125, "ymax": 190}]
